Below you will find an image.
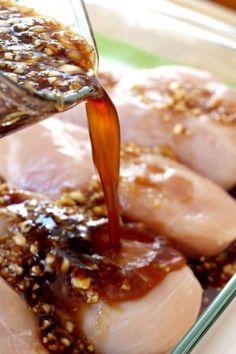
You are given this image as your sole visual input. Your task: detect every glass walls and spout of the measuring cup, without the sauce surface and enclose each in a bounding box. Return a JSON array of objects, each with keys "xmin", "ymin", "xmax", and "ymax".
[{"xmin": 0, "ymin": 0, "xmax": 98, "ymax": 137}]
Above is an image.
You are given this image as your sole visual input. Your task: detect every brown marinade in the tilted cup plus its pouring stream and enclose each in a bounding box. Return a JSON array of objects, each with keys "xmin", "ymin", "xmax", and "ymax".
[{"xmin": 0, "ymin": 0, "xmax": 120, "ymax": 251}]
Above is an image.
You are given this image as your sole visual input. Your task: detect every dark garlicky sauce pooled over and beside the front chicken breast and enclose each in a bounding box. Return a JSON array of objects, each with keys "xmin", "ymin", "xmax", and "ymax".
[{"xmin": 0, "ymin": 184, "xmax": 185, "ymax": 354}]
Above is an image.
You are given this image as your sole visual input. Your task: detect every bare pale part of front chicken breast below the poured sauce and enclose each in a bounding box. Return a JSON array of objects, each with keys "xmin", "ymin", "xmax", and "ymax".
[{"xmin": 82, "ymin": 267, "xmax": 201, "ymax": 354}]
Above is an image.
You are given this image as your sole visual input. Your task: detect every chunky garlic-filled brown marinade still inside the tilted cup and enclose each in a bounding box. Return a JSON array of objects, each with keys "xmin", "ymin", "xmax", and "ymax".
[{"xmin": 0, "ymin": 0, "xmax": 95, "ymax": 95}]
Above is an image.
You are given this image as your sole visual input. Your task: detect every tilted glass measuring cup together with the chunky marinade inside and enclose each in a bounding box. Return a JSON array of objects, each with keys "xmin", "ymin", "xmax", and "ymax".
[{"xmin": 0, "ymin": 0, "xmax": 99, "ymax": 137}]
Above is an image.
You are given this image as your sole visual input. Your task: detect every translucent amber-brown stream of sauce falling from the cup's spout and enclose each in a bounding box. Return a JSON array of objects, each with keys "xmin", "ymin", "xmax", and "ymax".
[{"xmin": 86, "ymin": 88, "xmax": 120, "ymax": 251}]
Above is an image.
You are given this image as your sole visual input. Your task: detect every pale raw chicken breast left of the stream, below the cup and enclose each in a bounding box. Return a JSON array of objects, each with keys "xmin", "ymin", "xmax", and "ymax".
[{"xmin": 0, "ymin": 118, "xmax": 94, "ymax": 196}]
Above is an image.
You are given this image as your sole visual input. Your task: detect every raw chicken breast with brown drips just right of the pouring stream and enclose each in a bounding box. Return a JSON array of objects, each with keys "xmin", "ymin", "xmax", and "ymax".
[{"xmin": 119, "ymin": 146, "xmax": 236, "ymax": 256}]
